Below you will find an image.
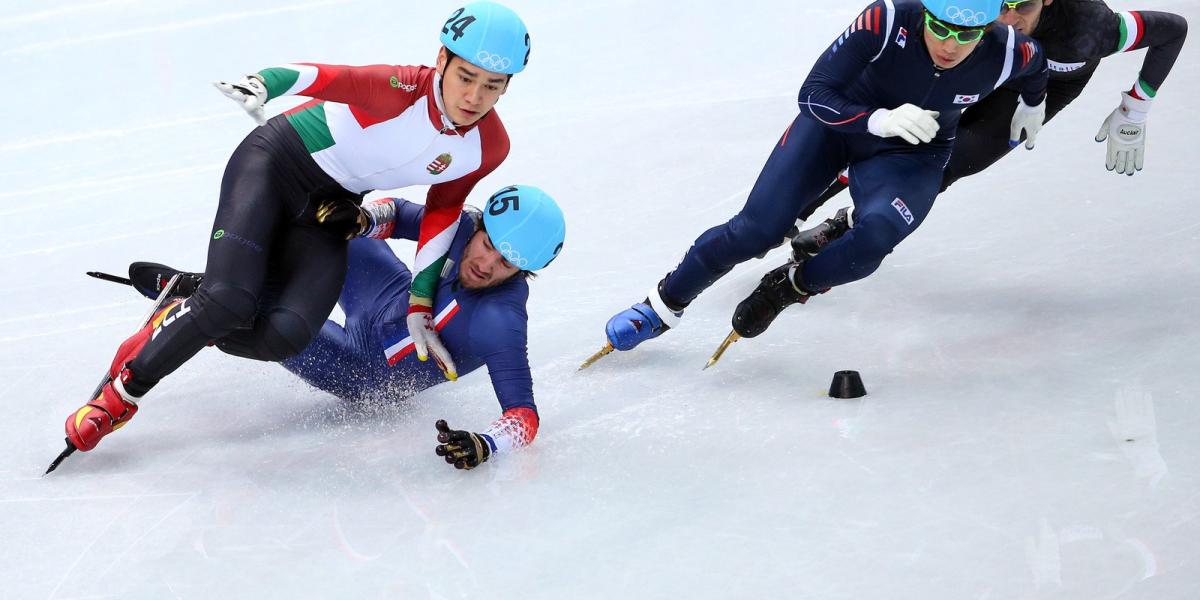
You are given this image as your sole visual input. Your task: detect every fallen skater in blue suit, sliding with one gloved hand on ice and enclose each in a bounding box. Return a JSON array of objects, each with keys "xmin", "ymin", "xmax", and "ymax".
[{"xmin": 283, "ymin": 186, "xmax": 565, "ymax": 468}]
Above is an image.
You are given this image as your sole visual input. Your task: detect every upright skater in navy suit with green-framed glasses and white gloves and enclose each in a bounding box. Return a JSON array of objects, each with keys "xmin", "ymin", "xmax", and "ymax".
[{"xmin": 592, "ymin": 0, "xmax": 1048, "ymax": 362}]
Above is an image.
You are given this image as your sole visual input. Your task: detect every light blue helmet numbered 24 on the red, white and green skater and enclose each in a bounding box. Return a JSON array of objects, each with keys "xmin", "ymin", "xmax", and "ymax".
[{"xmin": 442, "ymin": 2, "xmax": 529, "ymax": 74}]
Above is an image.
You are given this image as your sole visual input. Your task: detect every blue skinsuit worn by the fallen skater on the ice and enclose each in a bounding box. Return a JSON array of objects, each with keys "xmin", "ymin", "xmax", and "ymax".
[{"xmin": 283, "ymin": 199, "xmax": 536, "ymax": 410}]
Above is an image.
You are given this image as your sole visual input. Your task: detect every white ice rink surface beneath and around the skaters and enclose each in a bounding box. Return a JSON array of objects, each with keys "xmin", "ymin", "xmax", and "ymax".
[{"xmin": 0, "ymin": 0, "xmax": 1200, "ymax": 600}]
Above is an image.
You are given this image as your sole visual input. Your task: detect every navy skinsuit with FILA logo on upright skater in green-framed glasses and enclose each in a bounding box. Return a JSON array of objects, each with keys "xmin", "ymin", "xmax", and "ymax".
[{"xmin": 660, "ymin": 0, "xmax": 1046, "ymax": 308}]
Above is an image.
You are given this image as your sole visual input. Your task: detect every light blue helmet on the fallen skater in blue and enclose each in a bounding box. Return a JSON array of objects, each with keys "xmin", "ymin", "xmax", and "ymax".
[{"xmin": 484, "ymin": 186, "xmax": 566, "ymax": 271}]
